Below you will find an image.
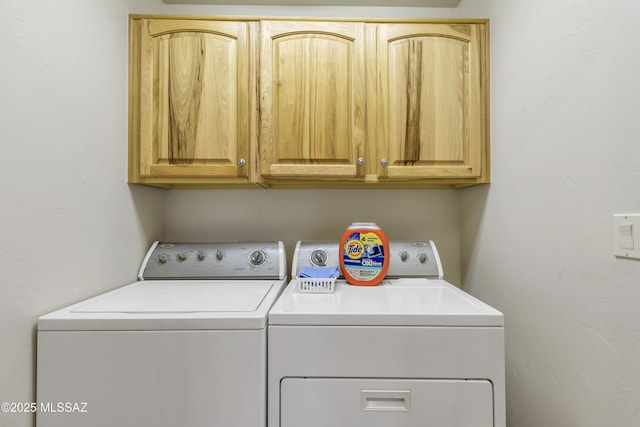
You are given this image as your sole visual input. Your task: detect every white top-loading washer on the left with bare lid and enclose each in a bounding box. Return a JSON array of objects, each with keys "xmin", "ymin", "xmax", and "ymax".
[{"xmin": 36, "ymin": 242, "xmax": 286, "ymax": 427}]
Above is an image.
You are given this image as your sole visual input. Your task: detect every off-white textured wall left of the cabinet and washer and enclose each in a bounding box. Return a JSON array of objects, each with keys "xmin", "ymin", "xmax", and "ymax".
[{"xmin": 0, "ymin": 0, "xmax": 164, "ymax": 427}]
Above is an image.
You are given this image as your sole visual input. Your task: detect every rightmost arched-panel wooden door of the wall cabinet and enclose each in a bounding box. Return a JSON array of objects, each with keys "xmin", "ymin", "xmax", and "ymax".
[{"xmin": 377, "ymin": 23, "xmax": 488, "ymax": 180}]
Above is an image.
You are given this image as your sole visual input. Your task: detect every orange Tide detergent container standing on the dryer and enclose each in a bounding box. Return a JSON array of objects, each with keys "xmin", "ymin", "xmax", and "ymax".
[{"xmin": 339, "ymin": 222, "xmax": 390, "ymax": 286}]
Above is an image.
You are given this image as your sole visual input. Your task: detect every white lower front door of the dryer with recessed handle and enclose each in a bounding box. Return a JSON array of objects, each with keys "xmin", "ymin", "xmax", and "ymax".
[{"xmin": 280, "ymin": 378, "xmax": 493, "ymax": 427}]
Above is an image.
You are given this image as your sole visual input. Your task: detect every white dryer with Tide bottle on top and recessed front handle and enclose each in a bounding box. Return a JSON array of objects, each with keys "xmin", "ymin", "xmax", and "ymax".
[{"xmin": 267, "ymin": 241, "xmax": 506, "ymax": 427}]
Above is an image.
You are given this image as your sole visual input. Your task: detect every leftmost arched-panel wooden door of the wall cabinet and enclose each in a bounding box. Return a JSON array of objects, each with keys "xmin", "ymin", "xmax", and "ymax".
[{"xmin": 130, "ymin": 19, "xmax": 257, "ymax": 183}]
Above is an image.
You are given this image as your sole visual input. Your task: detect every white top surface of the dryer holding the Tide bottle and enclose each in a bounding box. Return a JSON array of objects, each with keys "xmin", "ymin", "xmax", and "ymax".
[{"xmin": 269, "ymin": 279, "xmax": 504, "ymax": 327}]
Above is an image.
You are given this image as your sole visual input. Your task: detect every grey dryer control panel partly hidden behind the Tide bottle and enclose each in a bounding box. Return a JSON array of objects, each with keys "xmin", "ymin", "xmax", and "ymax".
[{"xmin": 291, "ymin": 240, "xmax": 443, "ymax": 279}]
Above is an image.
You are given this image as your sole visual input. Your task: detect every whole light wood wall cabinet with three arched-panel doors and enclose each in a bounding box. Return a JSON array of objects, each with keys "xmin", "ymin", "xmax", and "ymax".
[{"xmin": 129, "ymin": 15, "xmax": 490, "ymax": 188}]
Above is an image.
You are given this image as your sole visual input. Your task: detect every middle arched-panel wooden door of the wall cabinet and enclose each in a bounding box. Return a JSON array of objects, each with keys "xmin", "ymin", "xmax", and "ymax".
[{"xmin": 259, "ymin": 21, "xmax": 365, "ymax": 180}]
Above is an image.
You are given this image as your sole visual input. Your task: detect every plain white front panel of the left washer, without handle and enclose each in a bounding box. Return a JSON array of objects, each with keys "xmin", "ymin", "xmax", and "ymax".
[{"xmin": 36, "ymin": 329, "xmax": 267, "ymax": 427}]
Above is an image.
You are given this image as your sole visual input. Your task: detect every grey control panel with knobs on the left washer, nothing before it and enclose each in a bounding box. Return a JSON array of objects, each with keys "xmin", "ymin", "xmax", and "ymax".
[{"xmin": 139, "ymin": 242, "xmax": 286, "ymax": 280}]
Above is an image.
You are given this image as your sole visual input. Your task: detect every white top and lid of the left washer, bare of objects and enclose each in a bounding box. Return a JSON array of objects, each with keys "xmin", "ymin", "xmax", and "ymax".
[{"xmin": 38, "ymin": 280, "xmax": 284, "ymax": 330}]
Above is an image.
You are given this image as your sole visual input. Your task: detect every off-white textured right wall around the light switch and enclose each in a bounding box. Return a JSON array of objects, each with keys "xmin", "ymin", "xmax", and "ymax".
[{"xmin": 459, "ymin": 0, "xmax": 640, "ymax": 427}]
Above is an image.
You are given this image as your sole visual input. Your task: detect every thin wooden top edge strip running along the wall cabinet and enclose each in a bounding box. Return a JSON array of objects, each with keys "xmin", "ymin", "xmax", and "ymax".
[{"xmin": 129, "ymin": 14, "xmax": 489, "ymax": 24}]
